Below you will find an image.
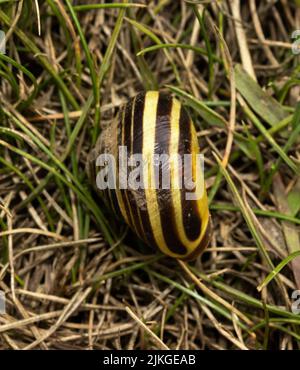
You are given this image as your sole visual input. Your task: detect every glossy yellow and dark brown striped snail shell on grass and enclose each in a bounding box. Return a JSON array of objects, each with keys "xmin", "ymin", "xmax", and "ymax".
[{"xmin": 88, "ymin": 91, "xmax": 211, "ymax": 260}]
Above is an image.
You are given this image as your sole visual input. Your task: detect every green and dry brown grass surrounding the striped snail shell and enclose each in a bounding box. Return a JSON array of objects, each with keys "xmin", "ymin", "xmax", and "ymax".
[{"xmin": 0, "ymin": 0, "xmax": 300, "ymax": 349}]
